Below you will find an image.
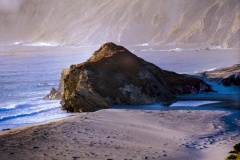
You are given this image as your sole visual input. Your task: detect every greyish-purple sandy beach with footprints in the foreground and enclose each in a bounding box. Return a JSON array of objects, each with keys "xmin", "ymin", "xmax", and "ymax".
[{"xmin": 0, "ymin": 106, "xmax": 240, "ymax": 160}]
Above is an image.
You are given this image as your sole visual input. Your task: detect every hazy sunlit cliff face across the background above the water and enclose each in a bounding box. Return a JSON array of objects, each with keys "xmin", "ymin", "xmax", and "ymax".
[{"xmin": 0, "ymin": 0, "xmax": 240, "ymax": 47}]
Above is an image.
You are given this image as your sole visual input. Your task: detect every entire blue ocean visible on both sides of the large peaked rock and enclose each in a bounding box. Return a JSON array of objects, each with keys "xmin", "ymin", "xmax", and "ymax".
[{"xmin": 0, "ymin": 46, "xmax": 239, "ymax": 130}]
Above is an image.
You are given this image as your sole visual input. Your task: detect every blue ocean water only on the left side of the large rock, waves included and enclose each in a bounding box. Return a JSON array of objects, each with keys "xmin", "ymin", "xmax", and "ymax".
[{"xmin": 0, "ymin": 48, "xmax": 93, "ymax": 129}]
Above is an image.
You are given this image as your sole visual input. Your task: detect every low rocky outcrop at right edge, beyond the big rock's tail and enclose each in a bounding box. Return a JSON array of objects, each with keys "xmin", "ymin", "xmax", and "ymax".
[{"xmin": 197, "ymin": 64, "xmax": 240, "ymax": 86}]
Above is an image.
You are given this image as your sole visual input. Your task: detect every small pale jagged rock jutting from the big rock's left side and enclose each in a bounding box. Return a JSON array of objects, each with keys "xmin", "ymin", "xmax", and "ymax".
[{"xmin": 44, "ymin": 68, "xmax": 69, "ymax": 100}]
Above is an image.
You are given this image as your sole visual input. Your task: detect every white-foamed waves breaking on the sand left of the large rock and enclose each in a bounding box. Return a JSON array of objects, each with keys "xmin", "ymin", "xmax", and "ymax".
[{"xmin": 0, "ymin": 98, "xmax": 74, "ymax": 129}]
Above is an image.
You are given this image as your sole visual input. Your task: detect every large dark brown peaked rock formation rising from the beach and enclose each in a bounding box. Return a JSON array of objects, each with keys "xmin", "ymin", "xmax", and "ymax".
[{"xmin": 62, "ymin": 43, "xmax": 210, "ymax": 112}]
